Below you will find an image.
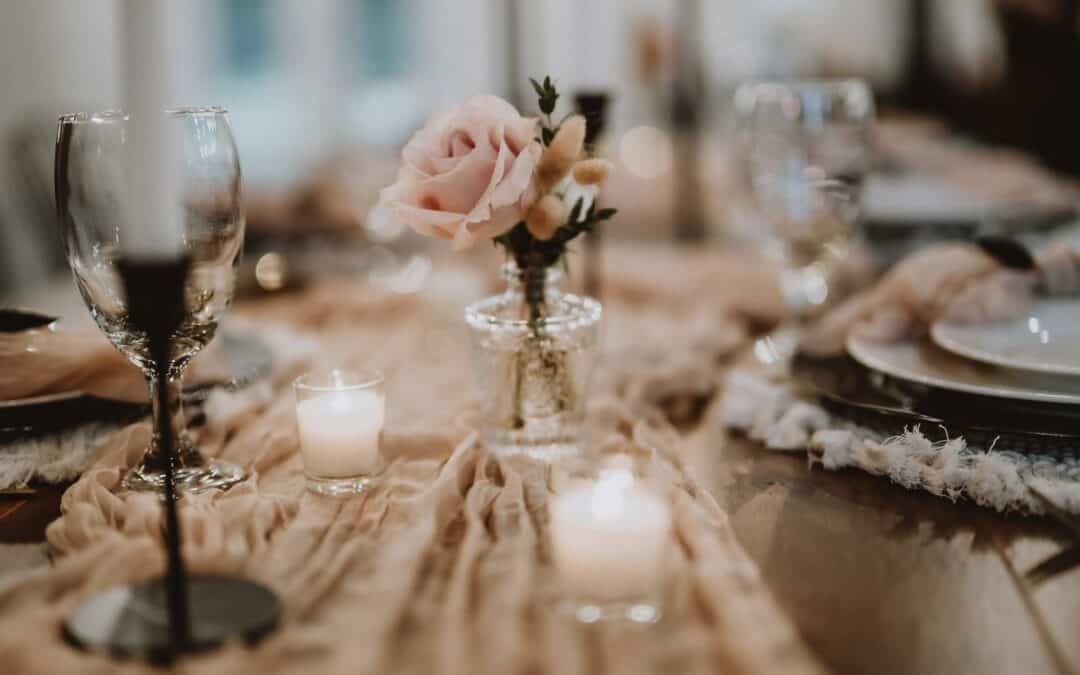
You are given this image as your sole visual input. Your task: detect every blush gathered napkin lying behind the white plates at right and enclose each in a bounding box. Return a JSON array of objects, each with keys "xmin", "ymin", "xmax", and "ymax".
[{"xmin": 800, "ymin": 243, "xmax": 1080, "ymax": 356}]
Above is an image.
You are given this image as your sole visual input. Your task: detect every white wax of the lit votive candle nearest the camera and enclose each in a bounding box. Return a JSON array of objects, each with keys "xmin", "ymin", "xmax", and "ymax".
[{"xmin": 551, "ymin": 470, "xmax": 672, "ymax": 602}]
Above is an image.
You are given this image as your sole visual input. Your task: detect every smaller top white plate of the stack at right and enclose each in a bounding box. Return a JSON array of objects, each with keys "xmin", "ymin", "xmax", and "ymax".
[{"xmin": 930, "ymin": 298, "xmax": 1080, "ymax": 375}]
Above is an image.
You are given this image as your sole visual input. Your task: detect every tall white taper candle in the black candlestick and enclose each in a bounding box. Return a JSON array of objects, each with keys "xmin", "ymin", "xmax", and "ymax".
[{"xmin": 120, "ymin": 0, "xmax": 184, "ymax": 258}]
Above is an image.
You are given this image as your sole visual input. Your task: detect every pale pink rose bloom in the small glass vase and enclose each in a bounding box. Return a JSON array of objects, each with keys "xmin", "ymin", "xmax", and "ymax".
[{"xmin": 379, "ymin": 96, "xmax": 540, "ymax": 249}]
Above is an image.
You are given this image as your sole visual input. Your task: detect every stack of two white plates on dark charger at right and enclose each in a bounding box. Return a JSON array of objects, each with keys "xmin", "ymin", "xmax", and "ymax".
[{"xmin": 797, "ymin": 299, "xmax": 1080, "ymax": 453}]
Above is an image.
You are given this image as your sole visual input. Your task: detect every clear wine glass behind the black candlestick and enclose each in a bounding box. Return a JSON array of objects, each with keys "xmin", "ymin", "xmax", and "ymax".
[{"xmin": 55, "ymin": 108, "xmax": 246, "ymax": 492}]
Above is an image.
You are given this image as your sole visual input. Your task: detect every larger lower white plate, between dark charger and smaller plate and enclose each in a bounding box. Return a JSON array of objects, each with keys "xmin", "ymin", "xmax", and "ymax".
[{"xmin": 848, "ymin": 336, "xmax": 1080, "ymax": 405}]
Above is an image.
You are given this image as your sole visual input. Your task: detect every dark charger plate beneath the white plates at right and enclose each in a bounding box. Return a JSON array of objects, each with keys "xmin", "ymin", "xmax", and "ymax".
[{"xmin": 792, "ymin": 355, "xmax": 1080, "ymax": 455}]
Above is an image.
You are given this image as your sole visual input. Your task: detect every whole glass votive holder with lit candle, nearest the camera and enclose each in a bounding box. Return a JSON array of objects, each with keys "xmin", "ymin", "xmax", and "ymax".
[{"xmin": 550, "ymin": 458, "xmax": 672, "ymax": 626}]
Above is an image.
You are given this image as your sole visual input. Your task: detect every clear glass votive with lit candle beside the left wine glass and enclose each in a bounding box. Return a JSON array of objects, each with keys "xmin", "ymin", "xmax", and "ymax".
[{"xmin": 294, "ymin": 368, "xmax": 387, "ymax": 496}]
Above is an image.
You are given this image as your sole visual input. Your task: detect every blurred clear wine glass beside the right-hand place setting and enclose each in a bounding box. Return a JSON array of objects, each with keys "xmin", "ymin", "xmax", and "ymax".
[{"xmin": 734, "ymin": 80, "xmax": 875, "ymax": 363}]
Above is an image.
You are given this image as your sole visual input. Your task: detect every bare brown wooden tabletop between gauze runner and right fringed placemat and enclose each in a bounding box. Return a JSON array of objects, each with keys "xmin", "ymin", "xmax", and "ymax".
[{"xmin": 691, "ymin": 422, "xmax": 1080, "ymax": 675}]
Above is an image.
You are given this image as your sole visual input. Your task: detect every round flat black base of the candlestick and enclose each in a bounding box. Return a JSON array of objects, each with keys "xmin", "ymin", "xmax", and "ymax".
[{"xmin": 64, "ymin": 576, "xmax": 281, "ymax": 662}]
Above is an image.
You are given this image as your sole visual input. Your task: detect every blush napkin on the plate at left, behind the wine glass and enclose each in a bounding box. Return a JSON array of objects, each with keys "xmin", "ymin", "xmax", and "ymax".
[{"xmin": 0, "ymin": 324, "xmax": 227, "ymax": 403}]
